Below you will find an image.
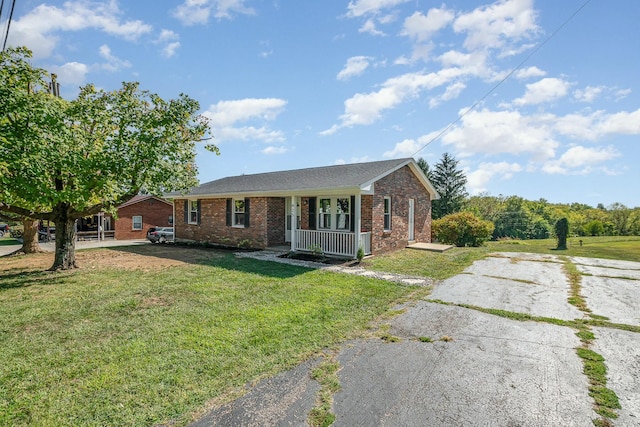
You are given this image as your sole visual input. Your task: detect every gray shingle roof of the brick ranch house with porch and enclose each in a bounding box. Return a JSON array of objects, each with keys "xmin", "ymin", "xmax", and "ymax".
[{"xmin": 174, "ymin": 158, "xmax": 436, "ymax": 197}]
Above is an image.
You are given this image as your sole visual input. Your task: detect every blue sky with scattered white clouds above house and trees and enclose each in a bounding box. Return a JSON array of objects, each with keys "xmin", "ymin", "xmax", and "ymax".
[{"xmin": 0, "ymin": 0, "xmax": 640, "ymax": 207}]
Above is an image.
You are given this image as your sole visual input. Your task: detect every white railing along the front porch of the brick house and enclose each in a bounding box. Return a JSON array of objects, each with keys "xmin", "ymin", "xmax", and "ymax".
[{"xmin": 295, "ymin": 230, "xmax": 371, "ymax": 257}]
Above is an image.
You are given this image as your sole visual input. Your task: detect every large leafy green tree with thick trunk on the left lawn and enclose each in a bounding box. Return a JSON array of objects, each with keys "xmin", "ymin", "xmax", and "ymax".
[{"xmin": 0, "ymin": 48, "xmax": 218, "ymax": 270}]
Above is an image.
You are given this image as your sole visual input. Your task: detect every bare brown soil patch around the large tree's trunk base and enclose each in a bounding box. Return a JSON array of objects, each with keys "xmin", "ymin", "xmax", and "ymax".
[{"xmin": 0, "ymin": 245, "xmax": 223, "ymax": 273}]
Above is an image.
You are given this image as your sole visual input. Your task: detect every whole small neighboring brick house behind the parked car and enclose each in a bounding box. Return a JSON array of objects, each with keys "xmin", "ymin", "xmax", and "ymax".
[{"xmin": 114, "ymin": 195, "xmax": 173, "ymax": 240}]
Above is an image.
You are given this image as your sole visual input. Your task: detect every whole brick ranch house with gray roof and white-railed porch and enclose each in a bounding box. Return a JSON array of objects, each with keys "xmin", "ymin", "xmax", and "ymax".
[{"xmin": 167, "ymin": 158, "xmax": 438, "ymax": 258}]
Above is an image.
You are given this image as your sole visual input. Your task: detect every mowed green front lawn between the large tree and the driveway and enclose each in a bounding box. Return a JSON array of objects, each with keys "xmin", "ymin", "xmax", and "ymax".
[{"xmin": 0, "ymin": 250, "xmax": 415, "ymax": 426}]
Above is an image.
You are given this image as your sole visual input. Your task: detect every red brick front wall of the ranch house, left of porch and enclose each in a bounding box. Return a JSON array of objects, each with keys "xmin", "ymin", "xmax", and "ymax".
[{"xmin": 175, "ymin": 197, "xmax": 284, "ymax": 249}]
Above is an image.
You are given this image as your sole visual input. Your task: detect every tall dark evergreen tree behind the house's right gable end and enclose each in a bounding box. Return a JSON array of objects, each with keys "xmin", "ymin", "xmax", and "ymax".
[{"xmin": 432, "ymin": 153, "xmax": 468, "ymax": 219}]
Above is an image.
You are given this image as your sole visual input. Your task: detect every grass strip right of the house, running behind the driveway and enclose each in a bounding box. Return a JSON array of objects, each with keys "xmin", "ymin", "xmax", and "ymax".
[{"xmin": 364, "ymin": 236, "xmax": 640, "ymax": 280}]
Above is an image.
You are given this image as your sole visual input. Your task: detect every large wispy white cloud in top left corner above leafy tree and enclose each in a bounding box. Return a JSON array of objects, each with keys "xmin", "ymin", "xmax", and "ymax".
[{"xmin": 9, "ymin": 1, "xmax": 152, "ymax": 58}]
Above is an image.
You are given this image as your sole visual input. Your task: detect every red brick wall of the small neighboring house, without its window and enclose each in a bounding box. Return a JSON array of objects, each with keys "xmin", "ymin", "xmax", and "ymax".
[{"xmin": 114, "ymin": 199, "xmax": 173, "ymax": 240}]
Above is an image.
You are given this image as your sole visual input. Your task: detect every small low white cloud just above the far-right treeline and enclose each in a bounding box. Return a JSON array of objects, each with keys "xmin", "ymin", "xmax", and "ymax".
[{"xmin": 542, "ymin": 145, "xmax": 620, "ymax": 175}]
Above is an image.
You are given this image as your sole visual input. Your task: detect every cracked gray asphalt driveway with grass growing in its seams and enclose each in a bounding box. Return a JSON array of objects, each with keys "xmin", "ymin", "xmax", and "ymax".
[{"xmin": 194, "ymin": 253, "xmax": 640, "ymax": 426}]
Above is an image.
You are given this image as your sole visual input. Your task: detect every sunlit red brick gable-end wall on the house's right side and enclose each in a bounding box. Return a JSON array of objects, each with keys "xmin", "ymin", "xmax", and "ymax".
[{"xmin": 363, "ymin": 166, "xmax": 431, "ymax": 254}]
